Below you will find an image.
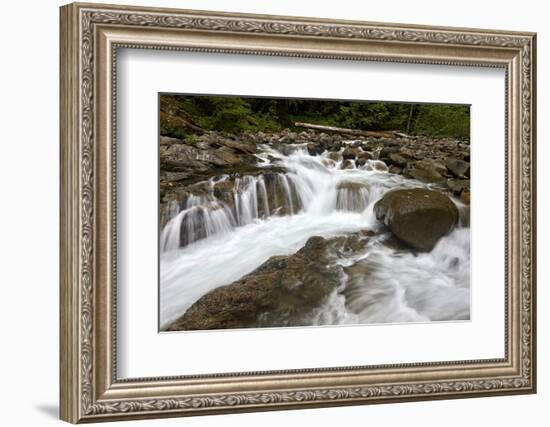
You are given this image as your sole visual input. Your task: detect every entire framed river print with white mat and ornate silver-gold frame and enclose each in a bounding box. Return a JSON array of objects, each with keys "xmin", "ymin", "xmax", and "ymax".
[{"xmin": 60, "ymin": 4, "xmax": 536, "ymax": 423}]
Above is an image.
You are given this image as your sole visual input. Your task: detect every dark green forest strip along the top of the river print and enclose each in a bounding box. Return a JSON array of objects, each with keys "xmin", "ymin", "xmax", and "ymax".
[{"xmin": 160, "ymin": 94, "xmax": 470, "ymax": 143}]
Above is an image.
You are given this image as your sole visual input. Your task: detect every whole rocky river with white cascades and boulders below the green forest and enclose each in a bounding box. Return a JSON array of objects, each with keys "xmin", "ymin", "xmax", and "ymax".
[{"xmin": 160, "ymin": 130, "xmax": 470, "ymax": 331}]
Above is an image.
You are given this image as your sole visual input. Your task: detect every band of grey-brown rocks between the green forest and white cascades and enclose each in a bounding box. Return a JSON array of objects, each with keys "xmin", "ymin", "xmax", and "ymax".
[{"xmin": 160, "ymin": 130, "xmax": 470, "ymax": 223}]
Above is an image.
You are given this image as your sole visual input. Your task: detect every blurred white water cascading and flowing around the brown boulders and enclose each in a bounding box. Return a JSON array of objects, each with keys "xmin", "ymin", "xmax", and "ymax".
[{"xmin": 160, "ymin": 145, "xmax": 470, "ymax": 328}]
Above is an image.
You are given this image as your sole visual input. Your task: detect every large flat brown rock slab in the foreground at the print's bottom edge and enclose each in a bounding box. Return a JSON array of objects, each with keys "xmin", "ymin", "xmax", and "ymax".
[{"xmin": 167, "ymin": 233, "xmax": 368, "ymax": 331}]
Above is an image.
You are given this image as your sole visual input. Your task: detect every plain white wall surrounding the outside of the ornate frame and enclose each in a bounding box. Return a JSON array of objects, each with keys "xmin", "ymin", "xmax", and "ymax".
[{"xmin": 0, "ymin": 0, "xmax": 550, "ymax": 427}]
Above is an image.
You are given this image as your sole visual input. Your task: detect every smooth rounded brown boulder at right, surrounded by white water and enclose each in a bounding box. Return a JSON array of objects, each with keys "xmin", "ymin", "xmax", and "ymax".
[{"xmin": 374, "ymin": 188, "xmax": 458, "ymax": 251}]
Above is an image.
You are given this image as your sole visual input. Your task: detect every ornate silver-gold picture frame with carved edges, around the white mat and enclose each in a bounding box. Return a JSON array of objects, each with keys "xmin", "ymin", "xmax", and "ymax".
[{"xmin": 60, "ymin": 3, "xmax": 536, "ymax": 423}]
